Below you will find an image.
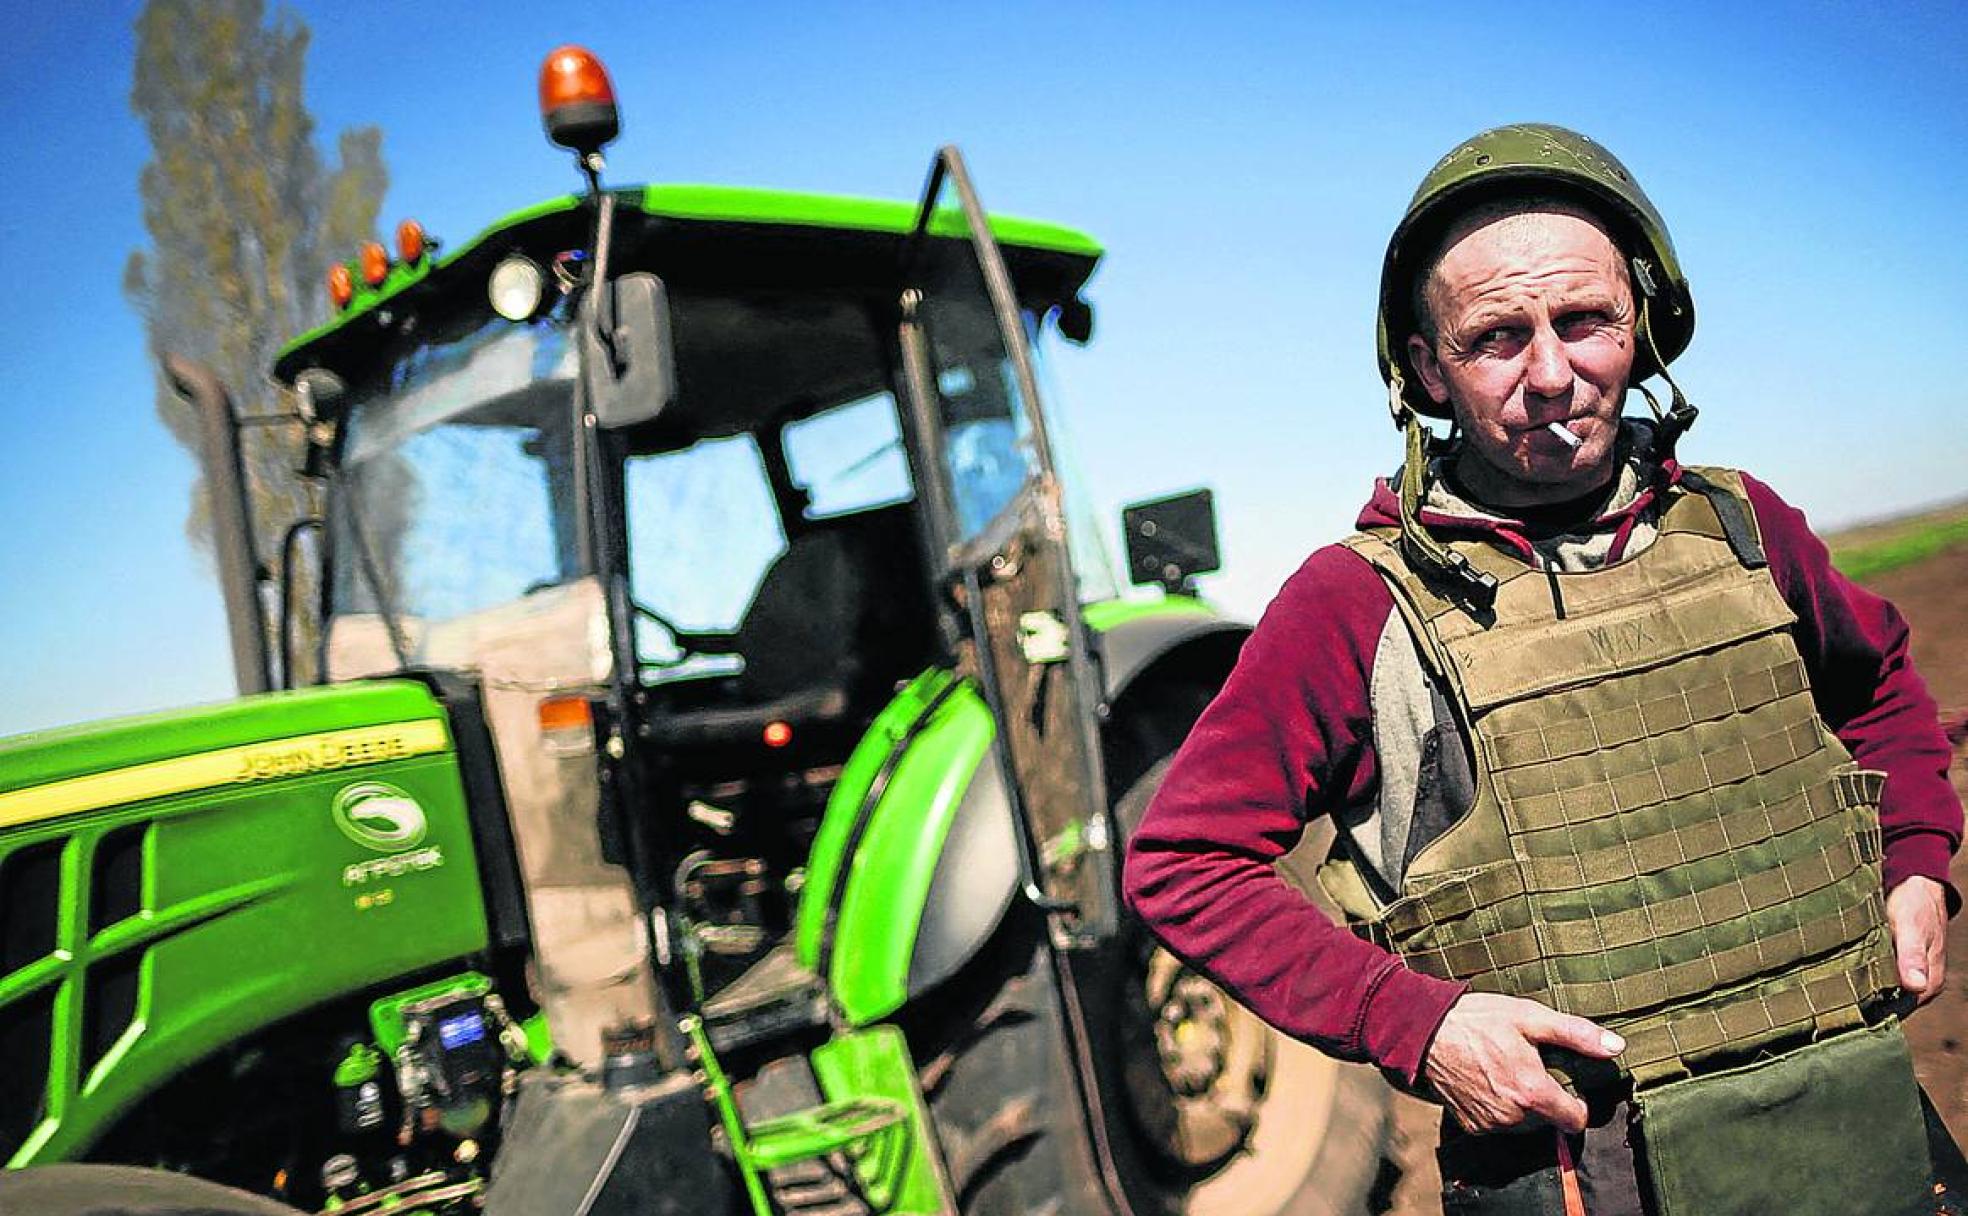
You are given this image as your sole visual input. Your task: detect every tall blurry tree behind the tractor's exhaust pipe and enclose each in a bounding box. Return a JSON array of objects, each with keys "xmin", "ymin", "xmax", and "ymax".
[{"xmin": 124, "ymin": 0, "xmax": 390, "ymax": 675}]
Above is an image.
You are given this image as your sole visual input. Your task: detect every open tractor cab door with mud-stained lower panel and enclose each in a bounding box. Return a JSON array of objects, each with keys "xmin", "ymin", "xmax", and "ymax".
[{"xmin": 901, "ymin": 148, "xmax": 1118, "ymax": 942}]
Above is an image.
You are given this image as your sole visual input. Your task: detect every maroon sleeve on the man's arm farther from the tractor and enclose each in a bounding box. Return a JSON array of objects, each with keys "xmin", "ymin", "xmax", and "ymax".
[{"xmin": 1742, "ymin": 474, "xmax": 1962, "ymax": 901}]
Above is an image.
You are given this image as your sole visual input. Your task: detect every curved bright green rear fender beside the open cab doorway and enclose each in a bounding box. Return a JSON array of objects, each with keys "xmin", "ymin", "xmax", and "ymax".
[{"xmin": 795, "ymin": 669, "xmax": 1017, "ymax": 1027}]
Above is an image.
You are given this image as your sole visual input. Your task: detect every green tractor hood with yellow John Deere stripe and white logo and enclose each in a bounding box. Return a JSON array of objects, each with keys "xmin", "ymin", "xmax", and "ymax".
[{"xmin": 0, "ymin": 681, "xmax": 486, "ymax": 1167}]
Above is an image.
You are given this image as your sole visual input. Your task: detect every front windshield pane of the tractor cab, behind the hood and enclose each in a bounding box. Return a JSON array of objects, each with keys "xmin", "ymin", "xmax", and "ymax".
[{"xmin": 331, "ymin": 321, "xmax": 579, "ymax": 659}]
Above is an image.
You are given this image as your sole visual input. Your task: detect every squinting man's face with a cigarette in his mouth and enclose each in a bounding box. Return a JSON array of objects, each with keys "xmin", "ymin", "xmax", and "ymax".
[{"xmin": 1407, "ymin": 209, "xmax": 1633, "ymax": 506}]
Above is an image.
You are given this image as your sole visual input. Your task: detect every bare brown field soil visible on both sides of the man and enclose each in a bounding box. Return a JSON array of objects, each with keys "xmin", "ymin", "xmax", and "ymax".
[{"xmin": 1376, "ymin": 545, "xmax": 1968, "ymax": 1216}]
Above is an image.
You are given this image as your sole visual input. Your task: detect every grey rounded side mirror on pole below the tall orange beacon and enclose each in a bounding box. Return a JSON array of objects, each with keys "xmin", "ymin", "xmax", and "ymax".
[{"xmin": 581, "ymin": 274, "xmax": 677, "ymax": 429}]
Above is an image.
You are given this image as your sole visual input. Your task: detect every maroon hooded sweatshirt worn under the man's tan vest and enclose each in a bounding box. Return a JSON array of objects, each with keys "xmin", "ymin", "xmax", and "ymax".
[{"xmin": 1126, "ymin": 464, "xmax": 1962, "ymax": 1086}]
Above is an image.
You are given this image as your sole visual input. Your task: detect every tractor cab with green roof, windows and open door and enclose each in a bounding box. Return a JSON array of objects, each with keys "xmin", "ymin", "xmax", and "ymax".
[{"xmin": 276, "ymin": 116, "xmax": 1116, "ymax": 1059}]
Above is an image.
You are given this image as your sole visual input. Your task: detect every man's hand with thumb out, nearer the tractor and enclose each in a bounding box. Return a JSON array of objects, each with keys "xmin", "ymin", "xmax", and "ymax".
[{"xmin": 1421, "ymin": 992, "xmax": 1626, "ymax": 1131}]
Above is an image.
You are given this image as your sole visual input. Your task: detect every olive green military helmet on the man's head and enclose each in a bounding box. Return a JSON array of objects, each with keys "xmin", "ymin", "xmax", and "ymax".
[{"xmin": 1378, "ymin": 122, "xmax": 1694, "ymax": 417}]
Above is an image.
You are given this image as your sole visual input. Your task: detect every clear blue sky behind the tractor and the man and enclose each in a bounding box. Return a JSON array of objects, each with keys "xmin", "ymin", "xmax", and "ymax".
[{"xmin": 0, "ymin": 0, "xmax": 1968, "ymax": 734}]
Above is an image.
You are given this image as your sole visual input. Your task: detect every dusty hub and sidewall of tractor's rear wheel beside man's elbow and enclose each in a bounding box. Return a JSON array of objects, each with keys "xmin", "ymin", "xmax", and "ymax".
[{"xmin": 1114, "ymin": 758, "xmax": 1391, "ymax": 1216}]
